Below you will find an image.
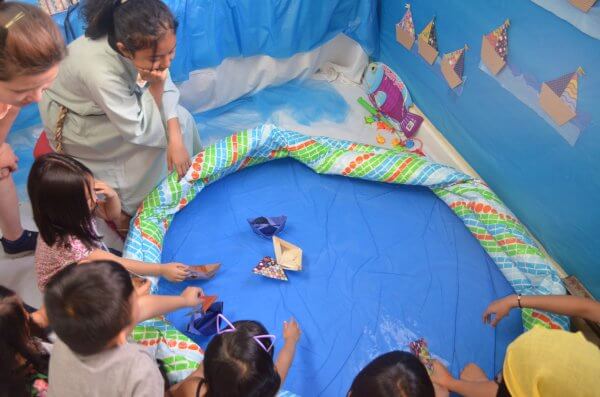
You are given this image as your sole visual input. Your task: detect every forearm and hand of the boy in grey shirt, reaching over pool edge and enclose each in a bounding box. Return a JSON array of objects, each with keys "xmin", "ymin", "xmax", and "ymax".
[{"xmin": 138, "ymin": 287, "xmax": 204, "ymax": 322}]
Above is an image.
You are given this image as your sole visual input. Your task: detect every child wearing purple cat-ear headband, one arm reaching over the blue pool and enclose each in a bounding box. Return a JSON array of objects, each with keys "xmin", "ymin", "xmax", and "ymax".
[{"xmin": 183, "ymin": 315, "xmax": 301, "ymax": 397}]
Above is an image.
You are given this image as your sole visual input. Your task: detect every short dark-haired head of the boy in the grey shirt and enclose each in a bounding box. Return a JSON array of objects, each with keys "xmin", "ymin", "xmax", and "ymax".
[{"xmin": 44, "ymin": 261, "xmax": 139, "ymax": 355}]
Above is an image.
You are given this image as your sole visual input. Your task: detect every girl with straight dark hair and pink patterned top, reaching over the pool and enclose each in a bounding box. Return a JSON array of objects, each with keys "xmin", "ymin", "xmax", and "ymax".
[{"xmin": 27, "ymin": 153, "xmax": 219, "ymax": 291}]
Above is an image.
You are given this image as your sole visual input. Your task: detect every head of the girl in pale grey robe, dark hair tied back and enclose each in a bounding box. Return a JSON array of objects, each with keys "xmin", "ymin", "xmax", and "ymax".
[{"xmin": 83, "ymin": 0, "xmax": 177, "ymax": 70}]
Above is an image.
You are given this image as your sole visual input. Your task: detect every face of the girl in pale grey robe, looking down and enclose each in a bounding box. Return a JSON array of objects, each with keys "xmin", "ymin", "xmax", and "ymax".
[{"xmin": 117, "ymin": 30, "xmax": 177, "ymax": 71}]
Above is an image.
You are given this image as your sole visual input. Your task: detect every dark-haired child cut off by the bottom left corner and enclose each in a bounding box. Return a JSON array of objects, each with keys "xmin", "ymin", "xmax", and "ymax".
[{"xmin": 0, "ymin": 286, "xmax": 49, "ymax": 397}]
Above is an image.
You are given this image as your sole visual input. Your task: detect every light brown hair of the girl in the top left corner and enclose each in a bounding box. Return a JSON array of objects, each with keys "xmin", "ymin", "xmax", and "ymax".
[{"xmin": 0, "ymin": 0, "xmax": 67, "ymax": 81}]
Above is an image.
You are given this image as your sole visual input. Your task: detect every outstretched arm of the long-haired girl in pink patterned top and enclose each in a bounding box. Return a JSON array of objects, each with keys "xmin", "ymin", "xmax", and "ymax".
[{"xmin": 82, "ymin": 249, "xmax": 188, "ymax": 281}]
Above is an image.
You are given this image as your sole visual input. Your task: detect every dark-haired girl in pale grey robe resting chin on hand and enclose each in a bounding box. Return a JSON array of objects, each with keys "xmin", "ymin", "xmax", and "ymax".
[{"xmin": 40, "ymin": 0, "xmax": 200, "ymax": 228}]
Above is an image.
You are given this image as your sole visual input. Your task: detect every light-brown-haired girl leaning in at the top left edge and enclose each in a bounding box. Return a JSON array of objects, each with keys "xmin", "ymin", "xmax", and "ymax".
[{"xmin": 0, "ymin": 0, "xmax": 66, "ymax": 256}]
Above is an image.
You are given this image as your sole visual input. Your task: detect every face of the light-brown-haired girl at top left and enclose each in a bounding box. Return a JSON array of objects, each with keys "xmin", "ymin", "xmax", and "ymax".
[{"xmin": 0, "ymin": 64, "xmax": 58, "ymax": 107}]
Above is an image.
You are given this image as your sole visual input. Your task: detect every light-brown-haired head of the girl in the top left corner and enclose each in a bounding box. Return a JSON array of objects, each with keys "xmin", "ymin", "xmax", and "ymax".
[{"xmin": 0, "ymin": 0, "xmax": 66, "ymax": 107}]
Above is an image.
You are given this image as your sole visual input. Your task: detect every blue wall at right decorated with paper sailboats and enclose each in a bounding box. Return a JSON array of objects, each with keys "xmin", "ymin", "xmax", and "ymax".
[{"xmin": 380, "ymin": 0, "xmax": 600, "ymax": 297}]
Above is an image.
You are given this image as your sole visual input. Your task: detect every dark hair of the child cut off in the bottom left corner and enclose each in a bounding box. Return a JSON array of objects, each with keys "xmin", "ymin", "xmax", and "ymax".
[{"xmin": 0, "ymin": 285, "xmax": 49, "ymax": 397}]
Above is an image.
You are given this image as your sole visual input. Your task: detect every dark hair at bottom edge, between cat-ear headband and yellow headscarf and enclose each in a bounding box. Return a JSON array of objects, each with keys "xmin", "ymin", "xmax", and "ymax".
[{"xmin": 349, "ymin": 351, "xmax": 435, "ymax": 397}]
